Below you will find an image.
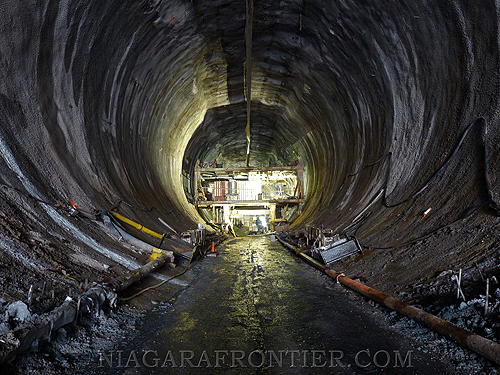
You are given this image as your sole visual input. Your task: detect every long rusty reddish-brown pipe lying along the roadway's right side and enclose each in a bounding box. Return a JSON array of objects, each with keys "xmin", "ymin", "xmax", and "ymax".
[{"xmin": 278, "ymin": 238, "xmax": 500, "ymax": 364}]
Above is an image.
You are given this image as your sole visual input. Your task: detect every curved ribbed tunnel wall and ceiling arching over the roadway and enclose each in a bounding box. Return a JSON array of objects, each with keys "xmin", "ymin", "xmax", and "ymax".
[{"xmin": 0, "ymin": 0, "xmax": 500, "ymax": 374}]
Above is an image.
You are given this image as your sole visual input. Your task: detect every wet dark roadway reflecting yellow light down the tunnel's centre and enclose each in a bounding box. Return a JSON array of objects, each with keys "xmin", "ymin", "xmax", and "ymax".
[{"xmin": 92, "ymin": 237, "xmax": 454, "ymax": 374}]
